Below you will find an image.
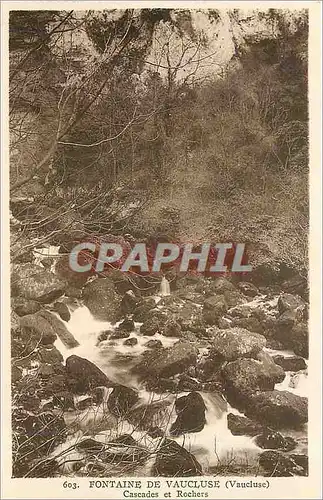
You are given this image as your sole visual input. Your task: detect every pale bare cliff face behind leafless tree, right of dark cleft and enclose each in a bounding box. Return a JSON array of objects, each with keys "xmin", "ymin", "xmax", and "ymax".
[{"xmin": 147, "ymin": 9, "xmax": 305, "ymax": 81}]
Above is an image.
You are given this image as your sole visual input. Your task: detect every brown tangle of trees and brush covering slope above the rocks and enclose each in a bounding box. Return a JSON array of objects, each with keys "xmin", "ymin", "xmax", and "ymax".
[{"xmin": 10, "ymin": 9, "xmax": 308, "ymax": 269}]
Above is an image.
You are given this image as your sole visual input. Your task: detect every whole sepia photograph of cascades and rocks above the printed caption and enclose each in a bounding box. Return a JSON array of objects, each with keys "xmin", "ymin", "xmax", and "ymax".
[{"xmin": 8, "ymin": 2, "xmax": 312, "ymax": 480}]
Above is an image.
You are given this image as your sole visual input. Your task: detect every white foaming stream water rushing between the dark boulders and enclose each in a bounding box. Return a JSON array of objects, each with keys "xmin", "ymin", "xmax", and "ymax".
[{"xmin": 55, "ymin": 298, "xmax": 307, "ymax": 475}]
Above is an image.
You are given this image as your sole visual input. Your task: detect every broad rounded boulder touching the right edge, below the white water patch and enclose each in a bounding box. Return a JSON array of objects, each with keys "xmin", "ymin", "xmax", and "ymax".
[{"xmin": 246, "ymin": 390, "xmax": 308, "ymax": 429}]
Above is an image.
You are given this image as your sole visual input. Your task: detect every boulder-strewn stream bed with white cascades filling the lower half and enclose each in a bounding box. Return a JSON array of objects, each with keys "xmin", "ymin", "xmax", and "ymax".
[{"xmin": 11, "ymin": 256, "xmax": 308, "ymax": 477}]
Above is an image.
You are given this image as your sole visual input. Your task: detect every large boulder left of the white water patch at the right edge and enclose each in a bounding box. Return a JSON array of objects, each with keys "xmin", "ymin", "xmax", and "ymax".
[{"xmin": 222, "ymin": 358, "xmax": 285, "ymax": 408}]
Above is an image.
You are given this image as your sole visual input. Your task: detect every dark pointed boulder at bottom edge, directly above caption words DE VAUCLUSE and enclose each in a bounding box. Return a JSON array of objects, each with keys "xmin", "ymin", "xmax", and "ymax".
[{"xmin": 152, "ymin": 439, "xmax": 202, "ymax": 477}]
